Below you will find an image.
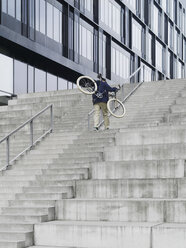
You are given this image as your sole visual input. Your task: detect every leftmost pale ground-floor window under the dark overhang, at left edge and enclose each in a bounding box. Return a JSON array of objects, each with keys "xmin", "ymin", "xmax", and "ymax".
[{"xmin": 0, "ymin": 54, "xmax": 13, "ymax": 94}]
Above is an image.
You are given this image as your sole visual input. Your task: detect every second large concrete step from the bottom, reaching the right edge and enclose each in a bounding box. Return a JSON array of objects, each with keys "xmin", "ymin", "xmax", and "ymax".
[{"xmin": 56, "ymin": 198, "xmax": 186, "ymax": 223}]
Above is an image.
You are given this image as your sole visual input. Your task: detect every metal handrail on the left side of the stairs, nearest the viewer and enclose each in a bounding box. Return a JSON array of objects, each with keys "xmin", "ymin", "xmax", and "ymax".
[{"xmin": 0, "ymin": 104, "xmax": 53, "ymax": 171}]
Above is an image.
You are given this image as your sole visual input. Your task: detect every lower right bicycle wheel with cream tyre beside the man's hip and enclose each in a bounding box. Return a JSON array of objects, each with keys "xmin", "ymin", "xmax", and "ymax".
[{"xmin": 107, "ymin": 98, "xmax": 126, "ymax": 118}]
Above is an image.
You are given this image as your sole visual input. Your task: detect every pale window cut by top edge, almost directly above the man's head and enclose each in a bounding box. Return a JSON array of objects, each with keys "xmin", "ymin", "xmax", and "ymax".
[{"xmin": 100, "ymin": 0, "xmax": 121, "ymax": 35}]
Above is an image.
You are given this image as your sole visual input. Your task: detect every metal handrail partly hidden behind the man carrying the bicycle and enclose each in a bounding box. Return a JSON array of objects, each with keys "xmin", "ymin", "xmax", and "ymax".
[{"xmin": 88, "ymin": 65, "xmax": 145, "ymax": 130}]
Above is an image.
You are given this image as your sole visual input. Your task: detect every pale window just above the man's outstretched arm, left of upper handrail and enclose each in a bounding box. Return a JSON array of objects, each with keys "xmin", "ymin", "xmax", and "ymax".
[{"xmin": 111, "ymin": 42, "xmax": 130, "ymax": 79}]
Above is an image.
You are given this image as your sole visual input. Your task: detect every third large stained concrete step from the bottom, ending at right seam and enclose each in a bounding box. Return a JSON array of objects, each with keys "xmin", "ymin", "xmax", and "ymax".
[{"xmin": 76, "ymin": 179, "xmax": 179, "ymax": 199}]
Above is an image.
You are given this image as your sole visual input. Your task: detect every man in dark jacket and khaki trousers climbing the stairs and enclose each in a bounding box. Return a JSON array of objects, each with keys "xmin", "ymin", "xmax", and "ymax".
[{"xmin": 92, "ymin": 73, "xmax": 118, "ymax": 130}]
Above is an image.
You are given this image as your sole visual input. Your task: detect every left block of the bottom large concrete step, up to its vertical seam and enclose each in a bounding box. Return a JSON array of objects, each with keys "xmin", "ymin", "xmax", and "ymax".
[{"xmin": 35, "ymin": 221, "xmax": 158, "ymax": 248}]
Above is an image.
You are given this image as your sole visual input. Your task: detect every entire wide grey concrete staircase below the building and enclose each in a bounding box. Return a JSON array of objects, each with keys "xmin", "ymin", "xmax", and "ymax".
[{"xmin": 0, "ymin": 80, "xmax": 186, "ymax": 248}]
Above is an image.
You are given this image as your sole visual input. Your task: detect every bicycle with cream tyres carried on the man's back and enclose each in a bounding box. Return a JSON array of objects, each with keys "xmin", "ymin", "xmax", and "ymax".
[{"xmin": 76, "ymin": 76, "xmax": 126, "ymax": 118}]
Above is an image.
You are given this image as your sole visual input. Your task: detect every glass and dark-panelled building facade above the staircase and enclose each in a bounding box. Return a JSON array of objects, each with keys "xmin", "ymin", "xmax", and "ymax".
[{"xmin": 0, "ymin": 0, "xmax": 186, "ymax": 94}]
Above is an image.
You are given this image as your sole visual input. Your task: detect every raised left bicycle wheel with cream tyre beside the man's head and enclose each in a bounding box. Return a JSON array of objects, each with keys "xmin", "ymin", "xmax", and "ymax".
[{"xmin": 76, "ymin": 76, "xmax": 97, "ymax": 95}]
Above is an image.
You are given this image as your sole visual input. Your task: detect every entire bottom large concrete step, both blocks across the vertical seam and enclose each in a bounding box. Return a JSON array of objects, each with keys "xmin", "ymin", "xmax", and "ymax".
[{"xmin": 32, "ymin": 221, "xmax": 186, "ymax": 248}]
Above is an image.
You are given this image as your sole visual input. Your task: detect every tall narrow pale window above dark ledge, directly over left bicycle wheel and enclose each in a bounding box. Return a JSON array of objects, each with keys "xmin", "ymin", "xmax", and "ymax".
[{"xmin": 80, "ymin": 19, "xmax": 93, "ymax": 61}]
